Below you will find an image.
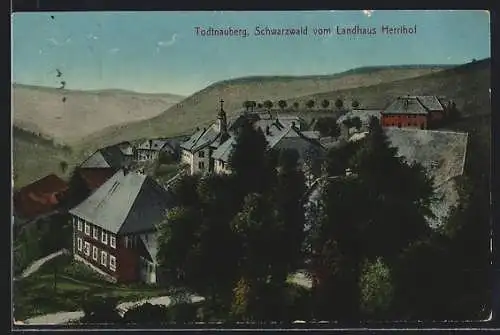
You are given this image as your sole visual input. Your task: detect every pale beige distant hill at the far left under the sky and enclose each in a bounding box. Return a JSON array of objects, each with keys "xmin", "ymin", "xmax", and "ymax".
[{"xmin": 12, "ymin": 84, "xmax": 183, "ymax": 144}]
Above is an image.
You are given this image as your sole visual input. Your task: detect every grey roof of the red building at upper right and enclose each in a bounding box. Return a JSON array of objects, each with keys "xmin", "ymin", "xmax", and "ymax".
[{"xmin": 382, "ymin": 96, "xmax": 444, "ymax": 114}]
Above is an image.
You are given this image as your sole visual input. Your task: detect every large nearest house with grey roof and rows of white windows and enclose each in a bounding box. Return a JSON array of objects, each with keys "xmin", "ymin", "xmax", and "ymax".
[{"xmin": 69, "ymin": 170, "xmax": 174, "ymax": 283}]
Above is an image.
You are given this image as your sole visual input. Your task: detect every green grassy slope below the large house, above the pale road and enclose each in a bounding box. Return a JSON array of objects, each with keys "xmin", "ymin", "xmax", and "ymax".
[{"xmin": 14, "ymin": 256, "xmax": 168, "ymax": 320}]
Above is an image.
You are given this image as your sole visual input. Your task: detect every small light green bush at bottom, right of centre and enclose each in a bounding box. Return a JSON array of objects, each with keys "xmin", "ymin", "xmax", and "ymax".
[{"xmin": 360, "ymin": 258, "xmax": 394, "ymax": 320}]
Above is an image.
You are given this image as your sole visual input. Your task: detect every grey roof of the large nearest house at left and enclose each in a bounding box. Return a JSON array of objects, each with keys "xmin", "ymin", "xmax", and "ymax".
[{"xmin": 70, "ymin": 170, "xmax": 173, "ymax": 234}]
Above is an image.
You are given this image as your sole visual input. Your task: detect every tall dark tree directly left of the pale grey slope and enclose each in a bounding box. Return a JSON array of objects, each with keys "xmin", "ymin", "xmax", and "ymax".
[{"xmin": 350, "ymin": 118, "xmax": 435, "ymax": 261}]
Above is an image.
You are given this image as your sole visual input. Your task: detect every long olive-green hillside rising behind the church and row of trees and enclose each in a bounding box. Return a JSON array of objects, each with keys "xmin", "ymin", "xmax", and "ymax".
[{"xmin": 81, "ymin": 65, "xmax": 447, "ymax": 147}]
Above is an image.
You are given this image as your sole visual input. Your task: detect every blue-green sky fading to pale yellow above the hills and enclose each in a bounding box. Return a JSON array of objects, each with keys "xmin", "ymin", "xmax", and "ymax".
[{"xmin": 12, "ymin": 10, "xmax": 490, "ymax": 95}]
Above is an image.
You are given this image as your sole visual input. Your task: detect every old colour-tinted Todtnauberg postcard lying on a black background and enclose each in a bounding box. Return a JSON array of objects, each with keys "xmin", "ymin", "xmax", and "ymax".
[{"xmin": 12, "ymin": 10, "xmax": 493, "ymax": 328}]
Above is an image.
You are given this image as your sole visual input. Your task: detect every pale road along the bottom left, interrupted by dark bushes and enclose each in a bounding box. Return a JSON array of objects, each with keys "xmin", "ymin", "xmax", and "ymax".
[{"xmin": 15, "ymin": 295, "xmax": 204, "ymax": 325}]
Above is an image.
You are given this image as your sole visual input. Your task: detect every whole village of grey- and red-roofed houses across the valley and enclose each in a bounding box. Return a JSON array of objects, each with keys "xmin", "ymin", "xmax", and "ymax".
[{"xmin": 13, "ymin": 95, "xmax": 468, "ymax": 326}]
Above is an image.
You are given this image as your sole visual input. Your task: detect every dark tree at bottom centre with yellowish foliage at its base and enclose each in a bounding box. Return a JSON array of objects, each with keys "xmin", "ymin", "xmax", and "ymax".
[{"xmin": 231, "ymin": 193, "xmax": 290, "ymax": 320}]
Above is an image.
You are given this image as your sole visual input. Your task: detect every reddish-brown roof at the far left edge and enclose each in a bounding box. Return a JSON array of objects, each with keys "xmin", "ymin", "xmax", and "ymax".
[{"xmin": 14, "ymin": 174, "xmax": 68, "ymax": 219}]
